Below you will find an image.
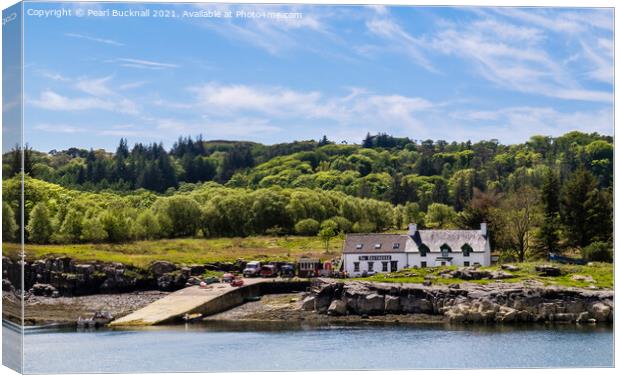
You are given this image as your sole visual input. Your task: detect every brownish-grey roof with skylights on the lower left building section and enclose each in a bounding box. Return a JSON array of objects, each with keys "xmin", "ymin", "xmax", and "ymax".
[{"xmin": 343, "ymin": 233, "xmax": 409, "ymax": 254}]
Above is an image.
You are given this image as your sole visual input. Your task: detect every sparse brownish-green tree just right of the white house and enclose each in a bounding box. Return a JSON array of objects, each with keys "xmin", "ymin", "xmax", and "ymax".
[{"xmin": 494, "ymin": 187, "xmax": 539, "ymax": 262}]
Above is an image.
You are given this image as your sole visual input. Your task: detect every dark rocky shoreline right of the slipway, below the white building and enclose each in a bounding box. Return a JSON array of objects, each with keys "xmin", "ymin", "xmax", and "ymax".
[{"xmin": 300, "ymin": 279, "xmax": 614, "ymax": 323}]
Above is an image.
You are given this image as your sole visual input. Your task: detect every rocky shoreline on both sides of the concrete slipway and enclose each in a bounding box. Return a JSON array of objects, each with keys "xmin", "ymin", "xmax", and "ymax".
[{"xmin": 3, "ymin": 279, "xmax": 613, "ymax": 327}]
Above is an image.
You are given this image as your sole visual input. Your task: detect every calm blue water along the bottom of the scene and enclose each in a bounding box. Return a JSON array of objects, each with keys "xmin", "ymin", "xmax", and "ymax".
[{"xmin": 14, "ymin": 323, "xmax": 613, "ymax": 373}]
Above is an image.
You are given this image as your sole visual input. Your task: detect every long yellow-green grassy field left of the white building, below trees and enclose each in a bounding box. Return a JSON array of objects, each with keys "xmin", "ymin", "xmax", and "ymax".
[{"xmin": 2, "ymin": 236, "xmax": 342, "ymax": 267}]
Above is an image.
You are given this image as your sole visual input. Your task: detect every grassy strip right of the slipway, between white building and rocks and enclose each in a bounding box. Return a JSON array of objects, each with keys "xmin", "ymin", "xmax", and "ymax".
[{"xmin": 360, "ymin": 262, "xmax": 614, "ymax": 289}]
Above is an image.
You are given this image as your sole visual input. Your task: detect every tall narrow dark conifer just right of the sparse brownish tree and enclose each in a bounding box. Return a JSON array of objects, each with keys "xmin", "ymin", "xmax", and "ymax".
[{"xmin": 536, "ymin": 169, "xmax": 560, "ymax": 254}]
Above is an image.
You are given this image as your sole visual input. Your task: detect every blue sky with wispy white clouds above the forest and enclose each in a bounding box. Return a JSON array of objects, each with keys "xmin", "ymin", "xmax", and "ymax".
[{"xmin": 19, "ymin": 3, "xmax": 613, "ymax": 151}]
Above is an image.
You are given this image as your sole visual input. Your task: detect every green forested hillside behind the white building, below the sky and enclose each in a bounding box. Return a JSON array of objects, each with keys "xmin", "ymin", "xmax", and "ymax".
[{"xmin": 3, "ymin": 132, "xmax": 613, "ymax": 259}]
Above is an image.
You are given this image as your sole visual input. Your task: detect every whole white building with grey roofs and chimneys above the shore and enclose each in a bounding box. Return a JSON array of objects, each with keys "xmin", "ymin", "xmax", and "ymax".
[{"xmin": 343, "ymin": 223, "xmax": 491, "ymax": 276}]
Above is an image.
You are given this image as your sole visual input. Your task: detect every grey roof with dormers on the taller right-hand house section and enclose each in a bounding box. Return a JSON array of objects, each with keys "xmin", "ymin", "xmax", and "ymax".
[{"xmin": 413, "ymin": 229, "xmax": 487, "ymax": 252}]
